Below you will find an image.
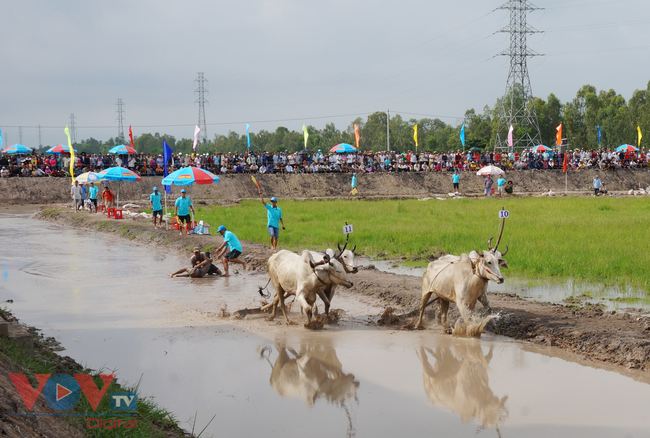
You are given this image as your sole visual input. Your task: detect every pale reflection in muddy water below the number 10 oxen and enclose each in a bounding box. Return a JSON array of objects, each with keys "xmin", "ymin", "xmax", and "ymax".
[{"xmin": 418, "ymin": 339, "xmax": 508, "ymax": 428}]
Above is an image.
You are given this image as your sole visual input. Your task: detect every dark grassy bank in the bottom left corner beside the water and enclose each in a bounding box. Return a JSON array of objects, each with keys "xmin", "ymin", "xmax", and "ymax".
[{"xmin": 0, "ymin": 308, "xmax": 190, "ymax": 438}]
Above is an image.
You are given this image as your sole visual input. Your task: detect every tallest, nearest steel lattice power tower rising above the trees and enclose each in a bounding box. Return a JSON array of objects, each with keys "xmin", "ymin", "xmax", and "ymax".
[{"xmin": 494, "ymin": 0, "xmax": 542, "ymax": 151}]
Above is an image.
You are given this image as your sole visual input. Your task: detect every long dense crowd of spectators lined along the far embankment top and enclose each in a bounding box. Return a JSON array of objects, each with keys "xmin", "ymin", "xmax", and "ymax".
[{"xmin": 0, "ymin": 149, "xmax": 650, "ymax": 177}]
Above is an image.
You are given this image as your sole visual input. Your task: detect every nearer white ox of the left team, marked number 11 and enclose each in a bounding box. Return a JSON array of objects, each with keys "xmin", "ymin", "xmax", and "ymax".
[{"xmin": 267, "ymin": 250, "xmax": 352, "ymax": 326}]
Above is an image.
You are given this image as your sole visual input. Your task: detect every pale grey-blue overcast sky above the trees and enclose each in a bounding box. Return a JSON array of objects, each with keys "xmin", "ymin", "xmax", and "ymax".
[{"xmin": 0, "ymin": 0, "xmax": 650, "ymax": 147}]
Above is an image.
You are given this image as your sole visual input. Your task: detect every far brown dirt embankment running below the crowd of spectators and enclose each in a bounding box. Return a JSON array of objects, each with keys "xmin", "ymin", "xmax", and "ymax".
[{"xmin": 5, "ymin": 170, "xmax": 650, "ymax": 204}]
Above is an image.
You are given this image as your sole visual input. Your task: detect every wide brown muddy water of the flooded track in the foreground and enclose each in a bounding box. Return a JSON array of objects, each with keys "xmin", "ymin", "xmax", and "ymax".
[{"xmin": 0, "ymin": 214, "xmax": 650, "ymax": 437}]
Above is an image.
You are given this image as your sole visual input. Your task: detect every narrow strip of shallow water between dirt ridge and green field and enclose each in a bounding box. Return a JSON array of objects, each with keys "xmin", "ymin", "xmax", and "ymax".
[{"xmin": 360, "ymin": 258, "xmax": 650, "ymax": 311}]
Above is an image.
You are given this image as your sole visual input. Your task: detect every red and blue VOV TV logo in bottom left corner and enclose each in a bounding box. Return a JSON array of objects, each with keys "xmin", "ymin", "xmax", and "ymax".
[{"xmin": 9, "ymin": 374, "xmax": 138, "ymax": 415}]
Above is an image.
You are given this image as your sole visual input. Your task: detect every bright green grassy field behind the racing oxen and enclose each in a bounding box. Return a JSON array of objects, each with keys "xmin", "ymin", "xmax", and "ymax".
[{"xmin": 192, "ymin": 198, "xmax": 650, "ymax": 291}]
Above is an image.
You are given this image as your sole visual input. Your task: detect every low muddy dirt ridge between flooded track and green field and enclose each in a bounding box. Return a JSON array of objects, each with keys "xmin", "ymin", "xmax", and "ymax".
[{"xmin": 37, "ymin": 211, "xmax": 650, "ymax": 370}]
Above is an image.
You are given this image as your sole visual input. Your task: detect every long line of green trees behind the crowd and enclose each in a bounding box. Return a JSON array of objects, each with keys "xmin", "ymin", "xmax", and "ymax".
[{"xmin": 40, "ymin": 82, "xmax": 650, "ymax": 154}]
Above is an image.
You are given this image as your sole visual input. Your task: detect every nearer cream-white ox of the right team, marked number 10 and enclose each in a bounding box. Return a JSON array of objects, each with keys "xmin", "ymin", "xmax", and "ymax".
[{"xmin": 415, "ymin": 251, "xmax": 504, "ymax": 328}]
